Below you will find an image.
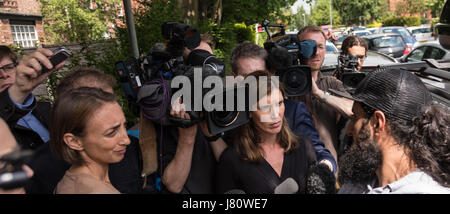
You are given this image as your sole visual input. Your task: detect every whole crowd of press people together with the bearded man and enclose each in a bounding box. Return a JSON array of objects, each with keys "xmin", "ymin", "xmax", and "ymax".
[{"xmin": 0, "ymin": 26, "xmax": 450, "ymax": 194}]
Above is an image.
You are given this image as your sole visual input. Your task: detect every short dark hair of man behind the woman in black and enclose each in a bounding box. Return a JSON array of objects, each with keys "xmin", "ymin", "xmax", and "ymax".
[{"xmin": 230, "ymin": 41, "xmax": 268, "ymax": 73}]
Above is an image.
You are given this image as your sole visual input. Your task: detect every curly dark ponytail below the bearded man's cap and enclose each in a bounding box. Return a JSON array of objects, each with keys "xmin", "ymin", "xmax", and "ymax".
[{"xmin": 386, "ymin": 105, "xmax": 450, "ymax": 187}]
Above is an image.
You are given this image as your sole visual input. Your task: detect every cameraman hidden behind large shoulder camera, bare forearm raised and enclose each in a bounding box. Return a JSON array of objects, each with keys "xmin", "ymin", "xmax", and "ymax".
[{"xmin": 116, "ymin": 22, "xmax": 232, "ymax": 193}]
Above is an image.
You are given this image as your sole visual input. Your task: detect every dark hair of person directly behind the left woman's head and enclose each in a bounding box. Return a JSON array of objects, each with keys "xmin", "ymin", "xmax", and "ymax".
[{"xmin": 56, "ymin": 67, "xmax": 116, "ymax": 97}]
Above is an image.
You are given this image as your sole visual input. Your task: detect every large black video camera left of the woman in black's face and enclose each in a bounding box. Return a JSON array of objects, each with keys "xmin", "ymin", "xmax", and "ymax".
[{"xmin": 116, "ymin": 22, "xmax": 249, "ymax": 134}]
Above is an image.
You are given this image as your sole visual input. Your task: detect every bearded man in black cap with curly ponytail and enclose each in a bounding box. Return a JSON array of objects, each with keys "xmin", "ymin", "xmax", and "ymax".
[{"xmin": 331, "ymin": 69, "xmax": 450, "ymax": 194}]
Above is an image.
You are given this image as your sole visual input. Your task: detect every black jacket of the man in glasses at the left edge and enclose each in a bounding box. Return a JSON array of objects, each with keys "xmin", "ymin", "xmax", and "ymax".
[{"xmin": 0, "ymin": 90, "xmax": 51, "ymax": 150}]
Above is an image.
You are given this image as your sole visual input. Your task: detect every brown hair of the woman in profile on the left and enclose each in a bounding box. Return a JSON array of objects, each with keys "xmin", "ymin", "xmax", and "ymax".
[{"xmin": 48, "ymin": 87, "xmax": 117, "ymax": 165}]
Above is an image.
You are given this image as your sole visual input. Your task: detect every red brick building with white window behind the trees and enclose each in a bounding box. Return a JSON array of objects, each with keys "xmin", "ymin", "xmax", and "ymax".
[{"xmin": 0, "ymin": 0, "xmax": 44, "ymax": 48}]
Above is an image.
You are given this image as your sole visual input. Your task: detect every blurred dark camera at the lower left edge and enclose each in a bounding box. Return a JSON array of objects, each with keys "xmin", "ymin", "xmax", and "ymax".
[{"xmin": 0, "ymin": 149, "xmax": 33, "ymax": 190}]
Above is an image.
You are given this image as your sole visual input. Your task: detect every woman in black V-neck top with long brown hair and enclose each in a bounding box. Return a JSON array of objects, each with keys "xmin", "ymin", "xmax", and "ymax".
[{"xmin": 217, "ymin": 71, "xmax": 316, "ymax": 194}]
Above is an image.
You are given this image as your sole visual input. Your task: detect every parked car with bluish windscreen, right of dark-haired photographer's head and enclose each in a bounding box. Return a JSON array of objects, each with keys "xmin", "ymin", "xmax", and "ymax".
[{"xmin": 363, "ymin": 33, "xmax": 411, "ymax": 58}]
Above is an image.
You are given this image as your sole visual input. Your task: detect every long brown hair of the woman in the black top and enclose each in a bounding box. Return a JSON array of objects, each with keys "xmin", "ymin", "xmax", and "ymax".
[{"xmin": 234, "ymin": 71, "xmax": 299, "ymax": 162}]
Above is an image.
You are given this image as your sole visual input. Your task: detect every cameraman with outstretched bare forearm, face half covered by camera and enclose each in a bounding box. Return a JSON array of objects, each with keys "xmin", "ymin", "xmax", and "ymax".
[{"xmin": 292, "ymin": 26, "xmax": 353, "ymax": 165}]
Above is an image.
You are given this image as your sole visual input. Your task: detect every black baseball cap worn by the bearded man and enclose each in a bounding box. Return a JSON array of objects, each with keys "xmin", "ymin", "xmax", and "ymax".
[{"xmin": 330, "ymin": 69, "xmax": 433, "ymax": 121}]
